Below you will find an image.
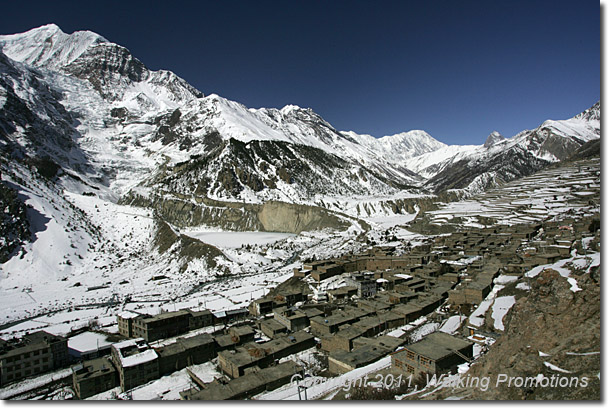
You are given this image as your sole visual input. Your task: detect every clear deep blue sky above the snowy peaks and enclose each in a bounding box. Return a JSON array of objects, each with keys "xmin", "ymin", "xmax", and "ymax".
[{"xmin": 0, "ymin": 0, "xmax": 600, "ymax": 144}]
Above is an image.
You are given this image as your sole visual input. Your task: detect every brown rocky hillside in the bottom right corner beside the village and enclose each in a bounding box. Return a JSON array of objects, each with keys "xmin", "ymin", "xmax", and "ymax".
[{"xmin": 421, "ymin": 267, "xmax": 601, "ymax": 400}]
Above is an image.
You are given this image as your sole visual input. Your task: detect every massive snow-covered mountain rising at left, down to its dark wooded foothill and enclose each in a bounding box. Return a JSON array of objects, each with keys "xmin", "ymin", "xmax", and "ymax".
[{"xmin": 0, "ymin": 25, "xmax": 436, "ymax": 218}]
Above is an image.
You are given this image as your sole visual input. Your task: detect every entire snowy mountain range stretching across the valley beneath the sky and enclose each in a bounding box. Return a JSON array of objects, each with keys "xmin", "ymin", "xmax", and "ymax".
[{"xmin": 0, "ymin": 24, "xmax": 600, "ymax": 234}]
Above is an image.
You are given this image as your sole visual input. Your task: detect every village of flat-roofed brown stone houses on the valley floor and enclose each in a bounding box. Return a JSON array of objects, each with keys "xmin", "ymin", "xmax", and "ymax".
[{"xmin": 0, "ymin": 210, "xmax": 600, "ymax": 400}]
